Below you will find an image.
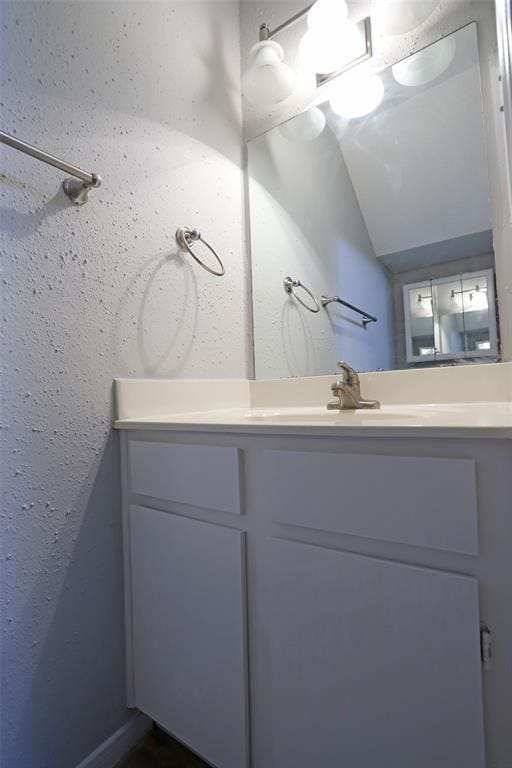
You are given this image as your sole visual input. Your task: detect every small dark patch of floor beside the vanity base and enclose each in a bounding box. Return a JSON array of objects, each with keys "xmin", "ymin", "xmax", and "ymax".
[{"xmin": 116, "ymin": 728, "xmax": 209, "ymax": 768}]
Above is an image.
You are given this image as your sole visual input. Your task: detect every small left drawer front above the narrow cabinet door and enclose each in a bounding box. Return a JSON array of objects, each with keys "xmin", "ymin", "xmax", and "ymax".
[{"xmin": 129, "ymin": 440, "xmax": 240, "ymax": 515}]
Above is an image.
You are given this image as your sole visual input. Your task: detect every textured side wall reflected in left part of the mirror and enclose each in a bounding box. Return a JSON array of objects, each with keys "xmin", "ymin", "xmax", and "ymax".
[{"xmin": 248, "ymin": 115, "xmax": 394, "ymax": 378}]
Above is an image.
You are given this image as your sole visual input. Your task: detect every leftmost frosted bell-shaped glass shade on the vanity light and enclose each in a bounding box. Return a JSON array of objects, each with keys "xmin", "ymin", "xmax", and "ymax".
[{"xmin": 242, "ymin": 40, "xmax": 295, "ymax": 104}]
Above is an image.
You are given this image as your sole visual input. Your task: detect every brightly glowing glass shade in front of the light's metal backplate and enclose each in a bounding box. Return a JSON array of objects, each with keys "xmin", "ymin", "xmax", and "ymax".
[{"xmin": 299, "ymin": 23, "xmax": 362, "ymax": 74}]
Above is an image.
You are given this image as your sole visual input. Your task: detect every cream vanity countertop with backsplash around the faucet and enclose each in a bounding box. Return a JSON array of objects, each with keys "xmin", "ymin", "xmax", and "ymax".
[{"xmin": 114, "ymin": 363, "xmax": 512, "ymax": 439}]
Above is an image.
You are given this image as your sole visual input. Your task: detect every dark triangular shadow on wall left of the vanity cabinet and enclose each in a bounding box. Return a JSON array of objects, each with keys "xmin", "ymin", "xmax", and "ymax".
[{"xmin": 2, "ymin": 434, "xmax": 125, "ymax": 768}]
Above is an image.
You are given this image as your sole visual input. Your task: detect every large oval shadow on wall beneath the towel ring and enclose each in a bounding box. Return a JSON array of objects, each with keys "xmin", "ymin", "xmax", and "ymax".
[{"xmin": 111, "ymin": 249, "xmax": 199, "ymax": 377}]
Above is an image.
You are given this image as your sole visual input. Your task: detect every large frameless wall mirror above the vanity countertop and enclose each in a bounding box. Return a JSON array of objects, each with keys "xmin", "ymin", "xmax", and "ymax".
[{"xmin": 248, "ymin": 24, "xmax": 499, "ymax": 378}]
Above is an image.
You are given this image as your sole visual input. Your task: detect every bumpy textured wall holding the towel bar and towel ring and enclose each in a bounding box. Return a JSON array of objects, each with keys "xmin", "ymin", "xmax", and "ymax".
[{"xmin": 0, "ymin": 0, "xmax": 248, "ymax": 768}]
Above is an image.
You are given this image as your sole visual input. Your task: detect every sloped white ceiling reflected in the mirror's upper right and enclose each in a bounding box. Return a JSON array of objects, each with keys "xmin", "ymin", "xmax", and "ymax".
[{"xmin": 330, "ymin": 25, "xmax": 491, "ymax": 271}]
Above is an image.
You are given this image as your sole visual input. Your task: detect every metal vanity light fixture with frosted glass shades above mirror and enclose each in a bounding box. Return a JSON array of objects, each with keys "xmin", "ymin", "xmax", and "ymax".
[{"xmin": 242, "ymin": 0, "xmax": 372, "ymax": 105}]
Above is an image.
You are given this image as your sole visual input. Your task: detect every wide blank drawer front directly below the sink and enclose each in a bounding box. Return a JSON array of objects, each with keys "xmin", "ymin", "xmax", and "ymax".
[{"xmin": 254, "ymin": 451, "xmax": 478, "ymax": 555}]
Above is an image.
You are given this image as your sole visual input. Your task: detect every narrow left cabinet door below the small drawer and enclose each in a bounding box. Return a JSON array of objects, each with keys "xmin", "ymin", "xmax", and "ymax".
[{"xmin": 130, "ymin": 506, "xmax": 248, "ymax": 768}]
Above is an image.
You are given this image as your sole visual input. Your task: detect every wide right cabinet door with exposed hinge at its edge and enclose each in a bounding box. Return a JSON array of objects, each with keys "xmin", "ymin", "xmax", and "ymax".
[{"xmin": 255, "ymin": 539, "xmax": 485, "ymax": 768}]
